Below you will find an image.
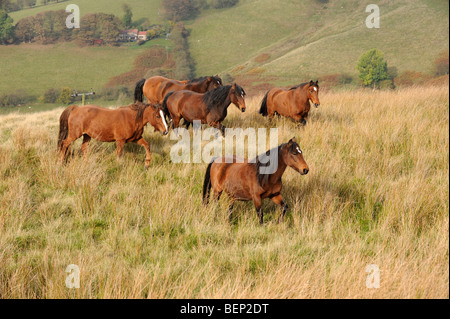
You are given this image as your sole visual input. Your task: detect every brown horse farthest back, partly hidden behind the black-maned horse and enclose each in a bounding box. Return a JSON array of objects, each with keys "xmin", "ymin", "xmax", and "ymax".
[{"xmin": 134, "ymin": 75, "xmax": 222, "ymax": 104}]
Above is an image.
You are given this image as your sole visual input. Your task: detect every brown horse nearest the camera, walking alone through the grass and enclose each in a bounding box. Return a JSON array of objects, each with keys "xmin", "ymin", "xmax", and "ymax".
[{"xmin": 203, "ymin": 138, "xmax": 309, "ymax": 224}]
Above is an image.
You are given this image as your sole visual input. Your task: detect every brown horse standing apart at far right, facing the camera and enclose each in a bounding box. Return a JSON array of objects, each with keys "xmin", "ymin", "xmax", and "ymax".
[{"xmin": 259, "ymin": 81, "xmax": 320, "ymax": 125}]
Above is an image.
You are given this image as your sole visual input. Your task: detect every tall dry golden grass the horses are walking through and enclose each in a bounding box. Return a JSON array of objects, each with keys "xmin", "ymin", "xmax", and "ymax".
[{"xmin": 0, "ymin": 87, "xmax": 449, "ymax": 298}]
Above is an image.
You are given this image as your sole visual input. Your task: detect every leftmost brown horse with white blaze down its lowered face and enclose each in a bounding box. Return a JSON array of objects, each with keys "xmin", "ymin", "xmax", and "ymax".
[{"xmin": 58, "ymin": 103, "xmax": 169, "ymax": 168}]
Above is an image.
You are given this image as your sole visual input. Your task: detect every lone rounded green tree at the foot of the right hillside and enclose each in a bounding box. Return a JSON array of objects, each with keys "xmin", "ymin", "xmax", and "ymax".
[{"xmin": 357, "ymin": 49, "xmax": 389, "ymax": 88}]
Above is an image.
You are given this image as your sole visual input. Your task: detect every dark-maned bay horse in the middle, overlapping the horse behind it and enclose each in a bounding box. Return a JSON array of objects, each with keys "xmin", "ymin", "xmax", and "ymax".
[{"xmin": 163, "ymin": 83, "xmax": 247, "ymax": 136}]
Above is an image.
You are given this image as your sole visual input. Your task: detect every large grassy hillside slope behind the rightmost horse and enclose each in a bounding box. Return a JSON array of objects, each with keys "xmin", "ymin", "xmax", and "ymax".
[{"xmin": 190, "ymin": 0, "xmax": 449, "ymax": 83}]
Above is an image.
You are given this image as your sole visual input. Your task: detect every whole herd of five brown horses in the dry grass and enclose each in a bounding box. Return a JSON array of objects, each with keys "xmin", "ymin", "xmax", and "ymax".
[{"xmin": 58, "ymin": 76, "xmax": 320, "ymax": 224}]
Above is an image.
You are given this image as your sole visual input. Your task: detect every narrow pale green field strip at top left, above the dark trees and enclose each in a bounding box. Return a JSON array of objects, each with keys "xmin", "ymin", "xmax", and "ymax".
[{"xmin": 10, "ymin": 0, "xmax": 163, "ymax": 24}]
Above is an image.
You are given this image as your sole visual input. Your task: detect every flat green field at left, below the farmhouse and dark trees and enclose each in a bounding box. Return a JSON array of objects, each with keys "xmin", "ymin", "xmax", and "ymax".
[{"xmin": 0, "ymin": 39, "xmax": 171, "ymax": 95}]
